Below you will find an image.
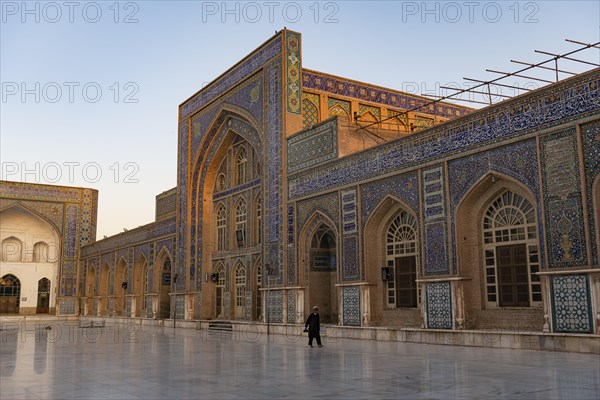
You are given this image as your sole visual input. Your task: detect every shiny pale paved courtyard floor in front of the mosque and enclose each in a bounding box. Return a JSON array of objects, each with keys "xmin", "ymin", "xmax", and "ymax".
[{"xmin": 0, "ymin": 321, "xmax": 600, "ymax": 400}]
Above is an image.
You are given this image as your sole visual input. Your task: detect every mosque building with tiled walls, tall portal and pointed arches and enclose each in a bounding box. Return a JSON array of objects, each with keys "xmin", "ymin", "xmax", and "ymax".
[{"xmin": 0, "ymin": 29, "xmax": 600, "ymax": 350}]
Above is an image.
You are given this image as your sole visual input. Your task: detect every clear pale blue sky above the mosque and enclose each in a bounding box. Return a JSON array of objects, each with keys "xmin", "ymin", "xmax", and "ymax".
[{"xmin": 0, "ymin": 1, "xmax": 600, "ymax": 238}]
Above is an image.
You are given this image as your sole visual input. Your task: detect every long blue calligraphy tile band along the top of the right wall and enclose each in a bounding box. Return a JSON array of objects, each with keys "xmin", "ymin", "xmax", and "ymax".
[{"xmin": 288, "ymin": 74, "xmax": 600, "ymax": 199}]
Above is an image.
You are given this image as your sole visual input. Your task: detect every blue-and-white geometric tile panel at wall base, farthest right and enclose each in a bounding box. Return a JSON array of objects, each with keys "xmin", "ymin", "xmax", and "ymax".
[{"xmin": 550, "ymin": 275, "xmax": 594, "ymax": 333}]
